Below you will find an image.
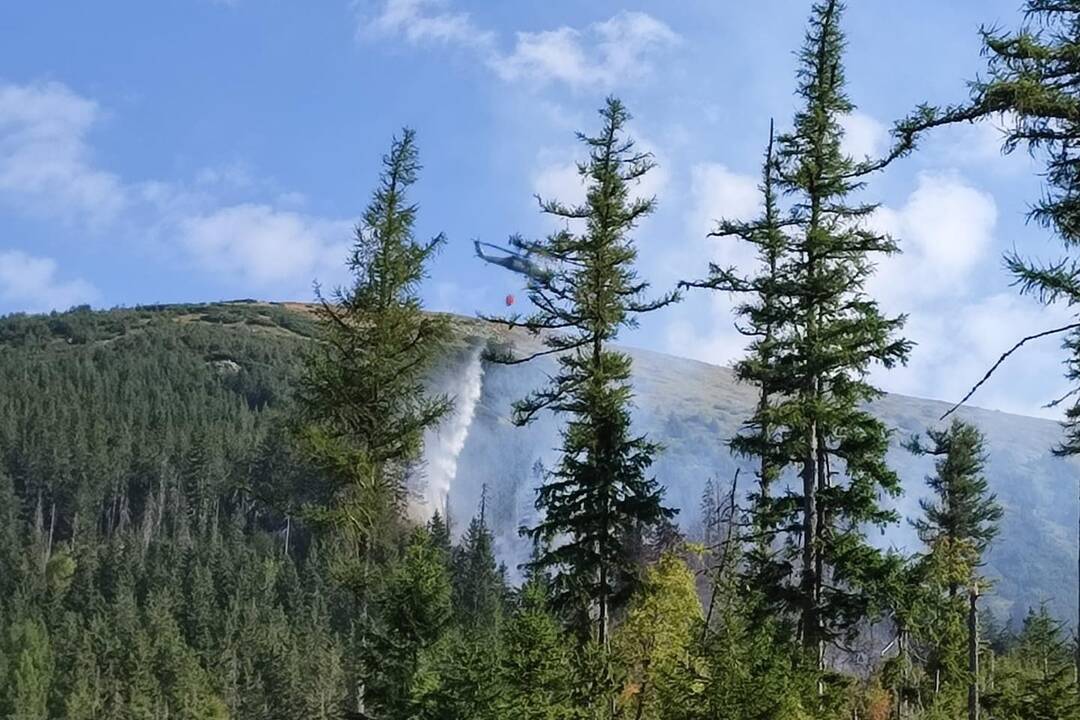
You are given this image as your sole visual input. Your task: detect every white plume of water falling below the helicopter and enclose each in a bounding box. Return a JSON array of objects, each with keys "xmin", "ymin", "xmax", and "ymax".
[{"xmin": 414, "ymin": 348, "xmax": 484, "ymax": 519}]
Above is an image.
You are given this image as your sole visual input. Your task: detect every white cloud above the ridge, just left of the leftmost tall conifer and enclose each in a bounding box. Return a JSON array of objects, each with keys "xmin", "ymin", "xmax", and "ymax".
[{"xmin": 178, "ymin": 204, "xmax": 349, "ymax": 289}]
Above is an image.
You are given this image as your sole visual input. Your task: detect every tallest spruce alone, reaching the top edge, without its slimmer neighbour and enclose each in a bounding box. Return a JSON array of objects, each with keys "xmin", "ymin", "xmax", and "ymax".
[{"xmin": 767, "ymin": 0, "xmax": 910, "ymax": 667}]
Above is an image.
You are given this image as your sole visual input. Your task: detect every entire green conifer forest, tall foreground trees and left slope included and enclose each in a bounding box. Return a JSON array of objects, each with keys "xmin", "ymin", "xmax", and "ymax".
[{"xmin": 8, "ymin": 0, "xmax": 1080, "ymax": 720}]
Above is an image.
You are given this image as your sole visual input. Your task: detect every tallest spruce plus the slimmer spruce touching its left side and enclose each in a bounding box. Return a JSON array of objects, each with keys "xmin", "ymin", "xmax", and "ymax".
[{"xmin": 693, "ymin": 0, "xmax": 910, "ymax": 677}]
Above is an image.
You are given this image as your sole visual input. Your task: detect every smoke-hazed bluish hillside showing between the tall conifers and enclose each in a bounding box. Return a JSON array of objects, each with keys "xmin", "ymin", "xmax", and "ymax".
[{"xmin": 414, "ymin": 337, "xmax": 1077, "ymax": 617}]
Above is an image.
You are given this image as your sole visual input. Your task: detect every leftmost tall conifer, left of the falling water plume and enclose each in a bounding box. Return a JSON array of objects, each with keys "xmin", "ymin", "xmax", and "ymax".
[{"xmin": 298, "ymin": 128, "xmax": 450, "ymax": 544}]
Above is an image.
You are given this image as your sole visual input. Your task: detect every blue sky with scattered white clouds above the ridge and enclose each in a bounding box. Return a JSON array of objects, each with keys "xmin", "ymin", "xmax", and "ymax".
[{"xmin": 0, "ymin": 0, "xmax": 1066, "ymax": 417}]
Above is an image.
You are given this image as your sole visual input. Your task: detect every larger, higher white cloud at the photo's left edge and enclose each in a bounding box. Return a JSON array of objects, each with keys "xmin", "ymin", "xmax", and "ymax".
[{"xmin": 0, "ymin": 82, "xmax": 127, "ymax": 223}]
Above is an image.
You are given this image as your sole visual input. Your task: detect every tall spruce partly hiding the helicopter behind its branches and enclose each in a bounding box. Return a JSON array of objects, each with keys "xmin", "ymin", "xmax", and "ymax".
[{"xmin": 495, "ymin": 97, "xmax": 677, "ymax": 646}]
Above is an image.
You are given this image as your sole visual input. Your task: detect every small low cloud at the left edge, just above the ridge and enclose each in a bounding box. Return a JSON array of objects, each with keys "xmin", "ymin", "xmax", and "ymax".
[{"xmin": 0, "ymin": 250, "xmax": 97, "ymax": 312}]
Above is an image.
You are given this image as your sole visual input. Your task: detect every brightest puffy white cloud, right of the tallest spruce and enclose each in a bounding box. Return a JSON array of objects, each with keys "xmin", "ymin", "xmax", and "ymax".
[{"xmin": 870, "ymin": 173, "xmax": 998, "ymax": 312}]
